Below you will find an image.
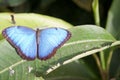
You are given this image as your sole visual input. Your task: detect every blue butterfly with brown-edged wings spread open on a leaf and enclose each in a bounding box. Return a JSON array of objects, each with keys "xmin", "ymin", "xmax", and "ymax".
[{"xmin": 2, "ymin": 26, "xmax": 71, "ymax": 60}]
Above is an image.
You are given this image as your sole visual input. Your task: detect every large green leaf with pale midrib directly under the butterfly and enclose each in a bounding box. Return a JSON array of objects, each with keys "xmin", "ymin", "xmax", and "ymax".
[{"xmin": 0, "ymin": 25, "xmax": 119, "ymax": 80}]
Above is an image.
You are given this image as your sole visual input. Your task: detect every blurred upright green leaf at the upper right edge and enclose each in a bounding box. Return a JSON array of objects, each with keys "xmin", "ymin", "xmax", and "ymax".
[{"xmin": 106, "ymin": 0, "xmax": 120, "ymax": 40}]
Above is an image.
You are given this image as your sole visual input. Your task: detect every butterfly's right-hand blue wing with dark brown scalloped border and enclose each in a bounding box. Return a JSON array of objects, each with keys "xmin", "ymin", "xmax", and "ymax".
[{"xmin": 37, "ymin": 28, "xmax": 71, "ymax": 60}]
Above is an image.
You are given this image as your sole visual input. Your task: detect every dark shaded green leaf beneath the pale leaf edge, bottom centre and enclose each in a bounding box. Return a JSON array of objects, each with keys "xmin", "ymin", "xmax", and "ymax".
[{"xmin": 46, "ymin": 60, "xmax": 99, "ymax": 80}]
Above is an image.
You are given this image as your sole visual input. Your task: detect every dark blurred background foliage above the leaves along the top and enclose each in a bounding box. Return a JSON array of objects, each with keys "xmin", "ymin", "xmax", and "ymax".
[{"xmin": 0, "ymin": 0, "xmax": 112, "ymax": 26}]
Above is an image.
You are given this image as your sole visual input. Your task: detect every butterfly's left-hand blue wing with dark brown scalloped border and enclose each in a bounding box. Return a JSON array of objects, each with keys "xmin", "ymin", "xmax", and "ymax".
[{"xmin": 2, "ymin": 26, "xmax": 37, "ymax": 60}]
